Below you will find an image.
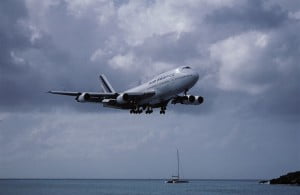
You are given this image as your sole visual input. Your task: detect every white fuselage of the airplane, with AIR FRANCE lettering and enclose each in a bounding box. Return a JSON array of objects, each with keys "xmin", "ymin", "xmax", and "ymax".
[{"xmin": 125, "ymin": 67, "xmax": 199, "ymax": 105}]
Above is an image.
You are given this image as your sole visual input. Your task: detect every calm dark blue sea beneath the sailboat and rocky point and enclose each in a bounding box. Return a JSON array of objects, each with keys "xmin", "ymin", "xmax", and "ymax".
[{"xmin": 0, "ymin": 179, "xmax": 300, "ymax": 195}]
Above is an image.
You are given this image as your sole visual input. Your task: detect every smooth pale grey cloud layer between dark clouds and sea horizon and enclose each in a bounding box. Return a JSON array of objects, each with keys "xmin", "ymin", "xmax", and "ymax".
[{"xmin": 0, "ymin": 110, "xmax": 299, "ymax": 178}]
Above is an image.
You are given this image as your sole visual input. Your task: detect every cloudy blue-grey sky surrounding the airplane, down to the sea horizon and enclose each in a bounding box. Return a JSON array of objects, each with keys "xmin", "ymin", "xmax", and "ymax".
[{"xmin": 0, "ymin": 0, "xmax": 300, "ymax": 179}]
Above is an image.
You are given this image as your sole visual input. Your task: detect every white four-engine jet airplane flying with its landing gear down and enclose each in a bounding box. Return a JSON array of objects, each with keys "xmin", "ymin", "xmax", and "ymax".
[{"xmin": 48, "ymin": 66, "xmax": 204, "ymax": 114}]
